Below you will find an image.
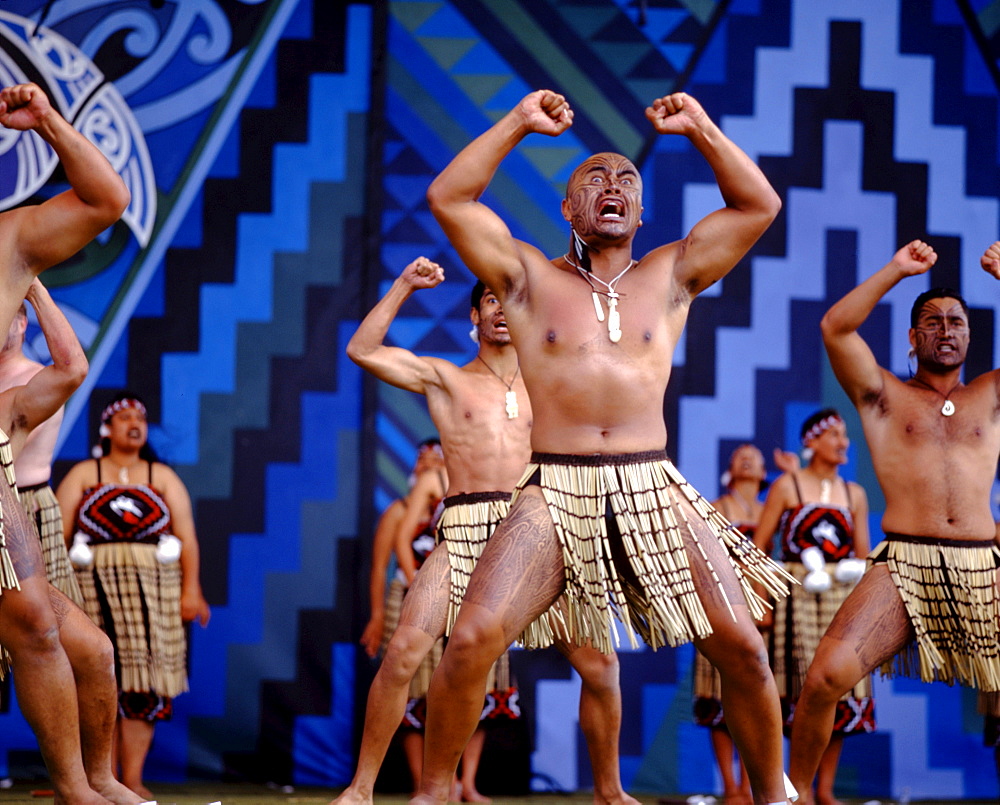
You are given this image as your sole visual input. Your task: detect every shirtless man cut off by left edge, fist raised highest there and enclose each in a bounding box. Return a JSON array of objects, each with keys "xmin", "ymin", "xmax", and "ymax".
[{"xmin": 0, "ymin": 84, "xmax": 141, "ymax": 805}]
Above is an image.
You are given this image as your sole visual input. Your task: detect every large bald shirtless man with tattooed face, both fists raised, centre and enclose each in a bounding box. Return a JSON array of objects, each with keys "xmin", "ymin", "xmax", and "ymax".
[{"xmin": 418, "ymin": 90, "xmax": 786, "ymax": 805}]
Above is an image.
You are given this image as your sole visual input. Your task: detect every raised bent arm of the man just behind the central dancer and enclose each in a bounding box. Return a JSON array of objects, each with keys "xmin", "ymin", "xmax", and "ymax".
[{"xmin": 347, "ymin": 257, "xmax": 444, "ymax": 394}]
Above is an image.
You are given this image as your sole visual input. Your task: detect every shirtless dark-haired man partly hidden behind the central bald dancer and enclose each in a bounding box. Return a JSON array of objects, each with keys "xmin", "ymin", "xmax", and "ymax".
[{"xmin": 335, "ymin": 257, "xmax": 635, "ymax": 803}]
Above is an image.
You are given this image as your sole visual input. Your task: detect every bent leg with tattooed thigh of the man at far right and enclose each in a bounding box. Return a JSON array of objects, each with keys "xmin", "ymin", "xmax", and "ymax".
[{"xmin": 788, "ymin": 564, "xmax": 914, "ymax": 801}]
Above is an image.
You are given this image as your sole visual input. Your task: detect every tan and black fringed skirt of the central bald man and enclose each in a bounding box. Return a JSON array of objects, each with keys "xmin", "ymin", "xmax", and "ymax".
[{"xmin": 515, "ymin": 452, "xmax": 791, "ymax": 654}]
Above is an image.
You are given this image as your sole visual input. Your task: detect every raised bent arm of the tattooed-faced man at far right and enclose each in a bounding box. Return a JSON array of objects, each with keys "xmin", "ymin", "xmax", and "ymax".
[{"xmin": 820, "ymin": 240, "xmax": 937, "ymax": 406}]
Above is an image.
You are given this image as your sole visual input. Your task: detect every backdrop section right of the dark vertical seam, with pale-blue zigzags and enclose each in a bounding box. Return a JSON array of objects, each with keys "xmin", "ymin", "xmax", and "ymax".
[{"xmin": 379, "ymin": 0, "xmax": 1000, "ymax": 796}]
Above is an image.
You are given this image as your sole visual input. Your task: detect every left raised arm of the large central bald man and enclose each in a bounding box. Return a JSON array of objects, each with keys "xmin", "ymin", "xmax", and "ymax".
[{"xmin": 427, "ymin": 90, "xmax": 573, "ymax": 301}]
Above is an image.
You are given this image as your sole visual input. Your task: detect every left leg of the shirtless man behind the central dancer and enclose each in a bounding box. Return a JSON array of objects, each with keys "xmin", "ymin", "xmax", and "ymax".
[{"xmin": 334, "ymin": 542, "xmax": 450, "ymax": 805}]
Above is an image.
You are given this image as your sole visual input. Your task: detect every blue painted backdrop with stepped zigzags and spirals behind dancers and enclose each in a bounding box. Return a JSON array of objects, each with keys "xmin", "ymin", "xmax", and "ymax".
[{"xmin": 0, "ymin": 0, "xmax": 1000, "ymax": 798}]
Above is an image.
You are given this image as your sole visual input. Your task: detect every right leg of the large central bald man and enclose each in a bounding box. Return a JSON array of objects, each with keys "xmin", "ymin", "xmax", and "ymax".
[{"xmin": 685, "ymin": 516, "xmax": 786, "ymax": 805}]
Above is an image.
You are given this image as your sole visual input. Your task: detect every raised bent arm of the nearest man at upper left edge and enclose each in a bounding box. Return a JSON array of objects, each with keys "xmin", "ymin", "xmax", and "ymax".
[{"xmin": 0, "ymin": 84, "xmax": 129, "ymax": 275}]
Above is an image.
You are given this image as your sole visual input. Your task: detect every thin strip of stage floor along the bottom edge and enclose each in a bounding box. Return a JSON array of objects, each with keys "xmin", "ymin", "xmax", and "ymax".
[{"xmin": 0, "ymin": 781, "xmax": 998, "ymax": 805}]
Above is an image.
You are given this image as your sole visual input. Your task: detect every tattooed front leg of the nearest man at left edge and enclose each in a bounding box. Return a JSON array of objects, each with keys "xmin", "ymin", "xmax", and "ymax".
[{"xmin": 0, "ymin": 483, "xmax": 107, "ymax": 805}]
